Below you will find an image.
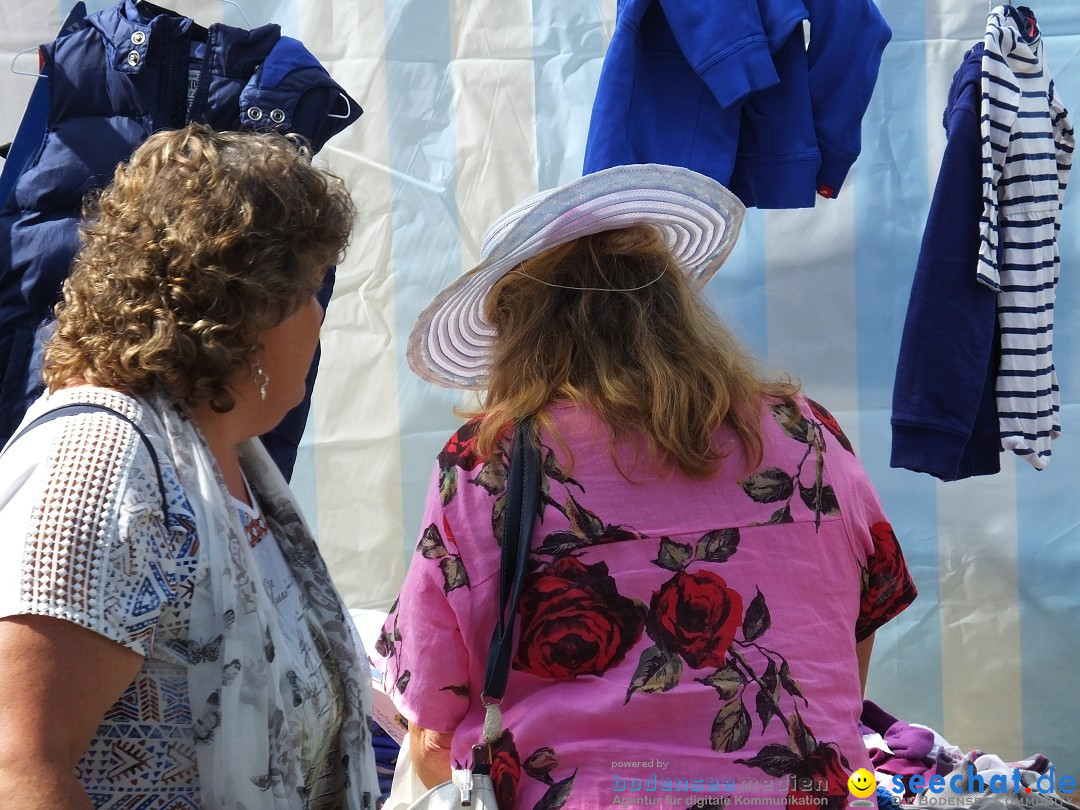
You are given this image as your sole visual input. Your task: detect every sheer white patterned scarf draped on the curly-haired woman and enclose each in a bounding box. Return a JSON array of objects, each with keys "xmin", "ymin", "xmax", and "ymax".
[{"xmin": 145, "ymin": 394, "xmax": 378, "ymax": 810}]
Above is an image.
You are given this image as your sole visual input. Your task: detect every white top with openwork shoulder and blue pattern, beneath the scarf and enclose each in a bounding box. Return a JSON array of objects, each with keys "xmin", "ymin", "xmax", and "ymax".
[{"xmin": 0, "ymin": 392, "xmax": 203, "ymax": 808}]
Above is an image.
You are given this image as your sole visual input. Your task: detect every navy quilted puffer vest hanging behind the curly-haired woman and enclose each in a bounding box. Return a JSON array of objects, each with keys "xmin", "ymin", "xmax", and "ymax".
[{"xmin": 0, "ymin": 0, "xmax": 362, "ymax": 477}]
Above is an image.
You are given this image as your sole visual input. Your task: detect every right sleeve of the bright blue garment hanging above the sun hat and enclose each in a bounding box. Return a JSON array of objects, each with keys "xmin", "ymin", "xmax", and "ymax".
[{"xmin": 806, "ymin": 0, "xmax": 892, "ymax": 197}]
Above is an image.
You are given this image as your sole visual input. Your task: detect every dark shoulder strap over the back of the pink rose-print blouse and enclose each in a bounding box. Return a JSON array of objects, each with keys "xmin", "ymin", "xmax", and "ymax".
[{"xmin": 484, "ymin": 419, "xmax": 540, "ymax": 702}]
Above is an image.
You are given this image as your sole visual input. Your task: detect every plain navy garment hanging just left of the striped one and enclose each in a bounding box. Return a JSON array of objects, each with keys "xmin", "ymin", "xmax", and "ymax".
[{"xmin": 891, "ymin": 42, "xmax": 1001, "ymax": 481}]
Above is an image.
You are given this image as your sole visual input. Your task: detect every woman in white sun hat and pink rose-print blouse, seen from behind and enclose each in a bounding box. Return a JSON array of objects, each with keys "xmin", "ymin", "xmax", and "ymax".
[{"xmin": 379, "ymin": 165, "xmax": 915, "ymax": 810}]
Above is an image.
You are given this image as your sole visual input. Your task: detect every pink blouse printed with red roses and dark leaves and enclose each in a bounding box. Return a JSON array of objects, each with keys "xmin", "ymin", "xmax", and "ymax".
[{"xmin": 378, "ymin": 399, "xmax": 916, "ymax": 810}]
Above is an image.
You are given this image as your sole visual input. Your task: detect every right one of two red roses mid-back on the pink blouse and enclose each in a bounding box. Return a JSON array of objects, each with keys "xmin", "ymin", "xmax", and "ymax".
[{"xmin": 648, "ymin": 571, "xmax": 743, "ymax": 670}]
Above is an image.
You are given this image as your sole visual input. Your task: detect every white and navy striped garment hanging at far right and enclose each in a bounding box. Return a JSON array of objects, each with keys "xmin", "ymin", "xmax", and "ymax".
[{"xmin": 977, "ymin": 5, "xmax": 1075, "ymax": 470}]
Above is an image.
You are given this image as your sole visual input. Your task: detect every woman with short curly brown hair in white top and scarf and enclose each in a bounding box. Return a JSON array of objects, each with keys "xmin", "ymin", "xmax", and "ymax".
[{"xmin": 0, "ymin": 125, "xmax": 377, "ymax": 810}]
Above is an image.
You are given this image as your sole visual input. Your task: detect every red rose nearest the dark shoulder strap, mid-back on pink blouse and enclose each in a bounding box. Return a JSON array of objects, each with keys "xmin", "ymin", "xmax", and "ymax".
[{"xmin": 514, "ymin": 556, "xmax": 645, "ymax": 678}]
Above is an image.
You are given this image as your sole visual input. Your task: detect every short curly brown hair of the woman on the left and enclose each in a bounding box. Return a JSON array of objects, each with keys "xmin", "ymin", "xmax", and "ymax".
[{"xmin": 44, "ymin": 124, "xmax": 355, "ymax": 411}]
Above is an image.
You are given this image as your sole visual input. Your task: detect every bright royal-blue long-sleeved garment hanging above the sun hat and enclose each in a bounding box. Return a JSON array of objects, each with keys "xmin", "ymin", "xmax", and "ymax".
[{"xmin": 584, "ymin": 0, "xmax": 892, "ymax": 208}]
